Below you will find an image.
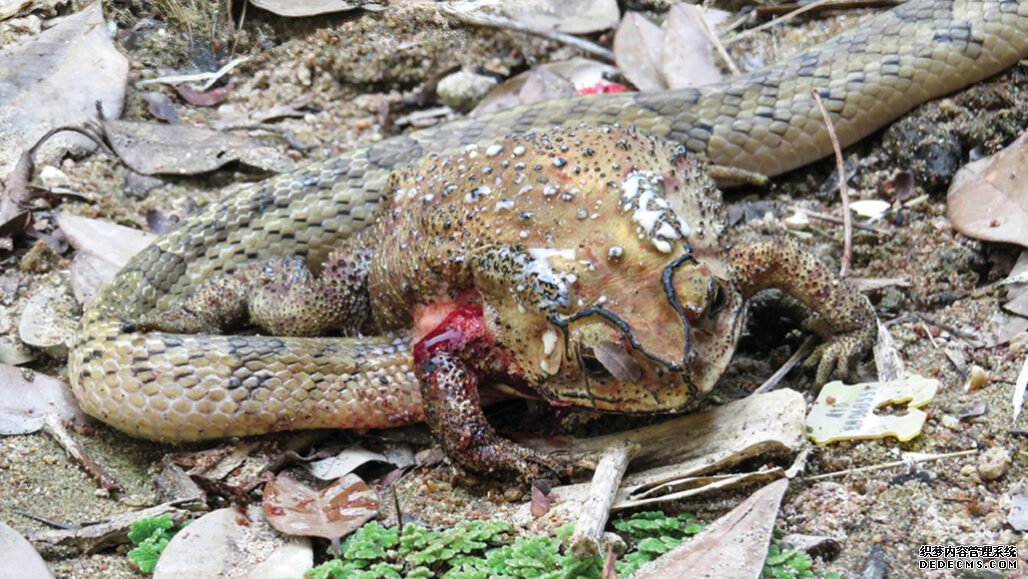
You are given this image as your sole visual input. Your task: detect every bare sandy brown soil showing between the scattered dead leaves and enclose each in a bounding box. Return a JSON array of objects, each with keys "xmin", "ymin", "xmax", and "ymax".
[{"xmin": 0, "ymin": 0, "xmax": 1028, "ymax": 577}]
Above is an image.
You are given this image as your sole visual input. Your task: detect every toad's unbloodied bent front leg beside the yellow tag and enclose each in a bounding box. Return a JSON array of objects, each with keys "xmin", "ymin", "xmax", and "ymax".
[{"xmin": 730, "ymin": 239, "xmax": 876, "ymax": 386}]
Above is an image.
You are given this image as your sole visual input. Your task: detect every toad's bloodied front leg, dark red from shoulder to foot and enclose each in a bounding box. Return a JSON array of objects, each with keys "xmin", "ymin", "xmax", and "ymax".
[{"xmin": 414, "ymin": 304, "xmax": 567, "ymax": 480}]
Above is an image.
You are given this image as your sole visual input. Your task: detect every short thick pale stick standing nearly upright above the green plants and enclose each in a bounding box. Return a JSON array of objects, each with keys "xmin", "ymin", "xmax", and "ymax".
[{"xmin": 571, "ymin": 440, "xmax": 639, "ymax": 558}]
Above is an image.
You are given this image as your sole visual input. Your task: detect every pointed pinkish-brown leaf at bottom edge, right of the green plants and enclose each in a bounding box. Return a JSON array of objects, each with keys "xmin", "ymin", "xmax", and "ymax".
[{"xmin": 632, "ymin": 479, "xmax": 788, "ymax": 579}]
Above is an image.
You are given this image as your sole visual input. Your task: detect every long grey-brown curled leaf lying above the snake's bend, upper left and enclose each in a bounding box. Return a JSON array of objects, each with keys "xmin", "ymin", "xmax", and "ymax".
[{"xmin": 104, "ymin": 120, "xmax": 292, "ymax": 175}]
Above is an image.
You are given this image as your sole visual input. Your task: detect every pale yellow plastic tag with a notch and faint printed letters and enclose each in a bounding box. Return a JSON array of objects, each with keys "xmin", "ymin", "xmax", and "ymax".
[{"xmin": 807, "ymin": 375, "xmax": 939, "ymax": 444}]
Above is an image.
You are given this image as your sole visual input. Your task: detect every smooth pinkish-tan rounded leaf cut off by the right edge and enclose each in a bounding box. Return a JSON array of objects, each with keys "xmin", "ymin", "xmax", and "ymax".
[{"xmin": 947, "ymin": 133, "xmax": 1028, "ymax": 247}]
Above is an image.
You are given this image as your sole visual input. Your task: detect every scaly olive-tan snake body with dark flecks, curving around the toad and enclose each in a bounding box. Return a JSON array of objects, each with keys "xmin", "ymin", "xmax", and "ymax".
[{"xmin": 69, "ymin": 0, "xmax": 1028, "ymax": 440}]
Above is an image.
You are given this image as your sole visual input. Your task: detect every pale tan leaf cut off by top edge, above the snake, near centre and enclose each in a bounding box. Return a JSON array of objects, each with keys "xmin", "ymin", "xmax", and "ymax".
[{"xmin": 501, "ymin": 0, "xmax": 621, "ymax": 34}]
